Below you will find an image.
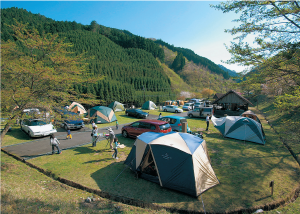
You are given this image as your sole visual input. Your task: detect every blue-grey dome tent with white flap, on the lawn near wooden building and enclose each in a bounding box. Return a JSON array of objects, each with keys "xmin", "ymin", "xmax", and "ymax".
[{"xmin": 211, "ymin": 116, "xmax": 266, "ymax": 144}]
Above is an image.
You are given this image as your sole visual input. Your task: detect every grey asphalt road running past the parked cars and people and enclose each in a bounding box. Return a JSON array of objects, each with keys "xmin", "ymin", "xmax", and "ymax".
[{"xmin": 2, "ymin": 112, "xmax": 187, "ymax": 159}]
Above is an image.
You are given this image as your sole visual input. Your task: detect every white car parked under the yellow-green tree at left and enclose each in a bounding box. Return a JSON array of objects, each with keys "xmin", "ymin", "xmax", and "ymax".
[{"xmin": 21, "ymin": 119, "xmax": 57, "ymax": 137}]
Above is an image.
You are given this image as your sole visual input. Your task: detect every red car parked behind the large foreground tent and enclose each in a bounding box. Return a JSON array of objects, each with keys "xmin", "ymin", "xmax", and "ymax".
[{"xmin": 122, "ymin": 120, "xmax": 172, "ymax": 137}]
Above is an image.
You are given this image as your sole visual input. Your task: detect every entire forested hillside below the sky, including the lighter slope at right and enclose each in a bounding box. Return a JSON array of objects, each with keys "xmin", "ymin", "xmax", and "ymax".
[{"xmin": 0, "ymin": 8, "xmax": 234, "ymax": 105}]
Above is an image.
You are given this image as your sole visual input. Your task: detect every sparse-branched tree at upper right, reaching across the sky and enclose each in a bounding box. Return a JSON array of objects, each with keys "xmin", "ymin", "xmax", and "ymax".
[{"xmin": 213, "ymin": 0, "xmax": 300, "ymax": 107}]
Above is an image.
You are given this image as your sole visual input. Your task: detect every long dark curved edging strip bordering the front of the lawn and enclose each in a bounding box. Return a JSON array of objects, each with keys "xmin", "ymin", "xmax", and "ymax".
[{"xmin": 1, "ymin": 145, "xmax": 300, "ymax": 214}]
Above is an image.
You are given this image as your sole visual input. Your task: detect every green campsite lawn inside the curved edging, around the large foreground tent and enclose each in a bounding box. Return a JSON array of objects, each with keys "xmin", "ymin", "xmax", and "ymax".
[{"xmin": 30, "ymin": 108, "xmax": 300, "ymax": 212}]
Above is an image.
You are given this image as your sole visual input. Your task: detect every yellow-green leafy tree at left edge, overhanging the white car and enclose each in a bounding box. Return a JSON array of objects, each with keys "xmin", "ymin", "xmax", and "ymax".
[{"xmin": 0, "ymin": 20, "xmax": 96, "ymax": 147}]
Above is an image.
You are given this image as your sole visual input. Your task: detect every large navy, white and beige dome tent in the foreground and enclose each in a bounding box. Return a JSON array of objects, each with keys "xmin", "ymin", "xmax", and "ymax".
[{"xmin": 124, "ymin": 132, "xmax": 219, "ymax": 197}]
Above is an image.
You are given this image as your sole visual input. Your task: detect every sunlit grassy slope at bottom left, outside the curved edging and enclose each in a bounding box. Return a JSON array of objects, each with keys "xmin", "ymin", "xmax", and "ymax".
[{"xmin": 0, "ymin": 152, "xmax": 167, "ymax": 214}]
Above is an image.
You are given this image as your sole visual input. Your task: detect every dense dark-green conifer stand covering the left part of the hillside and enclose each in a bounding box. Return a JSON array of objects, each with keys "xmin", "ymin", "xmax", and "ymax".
[{"xmin": 0, "ymin": 8, "xmax": 175, "ymax": 104}]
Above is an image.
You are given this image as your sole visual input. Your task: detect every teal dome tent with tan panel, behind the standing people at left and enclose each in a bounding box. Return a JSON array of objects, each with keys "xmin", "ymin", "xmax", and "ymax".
[{"xmin": 87, "ymin": 106, "xmax": 117, "ymax": 123}]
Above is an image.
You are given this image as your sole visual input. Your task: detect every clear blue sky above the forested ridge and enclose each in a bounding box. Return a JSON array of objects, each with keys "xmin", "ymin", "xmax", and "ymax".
[{"xmin": 0, "ymin": 0, "xmax": 245, "ymax": 72}]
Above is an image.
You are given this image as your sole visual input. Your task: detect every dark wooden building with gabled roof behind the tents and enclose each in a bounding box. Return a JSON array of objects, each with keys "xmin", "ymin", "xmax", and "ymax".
[{"xmin": 213, "ymin": 90, "xmax": 253, "ymax": 111}]
